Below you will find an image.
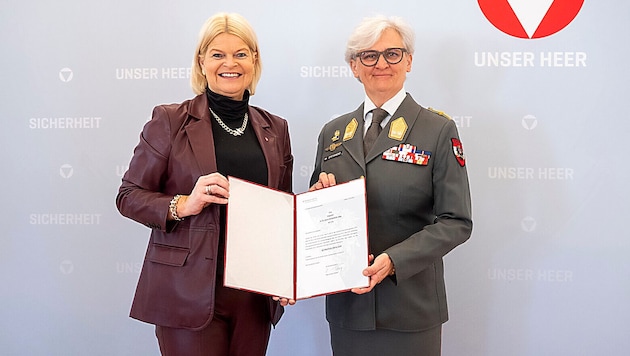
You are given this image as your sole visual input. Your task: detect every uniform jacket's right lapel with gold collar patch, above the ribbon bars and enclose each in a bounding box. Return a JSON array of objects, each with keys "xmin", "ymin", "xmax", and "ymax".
[{"xmin": 368, "ymin": 93, "xmax": 420, "ymax": 163}]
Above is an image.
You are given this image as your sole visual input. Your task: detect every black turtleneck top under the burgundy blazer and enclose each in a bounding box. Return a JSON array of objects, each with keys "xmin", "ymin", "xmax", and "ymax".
[{"xmin": 206, "ymin": 89, "xmax": 267, "ymax": 275}]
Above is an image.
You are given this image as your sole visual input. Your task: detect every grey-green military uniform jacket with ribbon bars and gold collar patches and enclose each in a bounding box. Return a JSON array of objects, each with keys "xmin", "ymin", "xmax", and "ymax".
[{"xmin": 311, "ymin": 94, "xmax": 472, "ymax": 331}]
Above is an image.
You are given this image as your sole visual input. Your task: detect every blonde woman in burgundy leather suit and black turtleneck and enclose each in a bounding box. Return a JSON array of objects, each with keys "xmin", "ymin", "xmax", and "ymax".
[{"xmin": 116, "ymin": 13, "xmax": 293, "ymax": 356}]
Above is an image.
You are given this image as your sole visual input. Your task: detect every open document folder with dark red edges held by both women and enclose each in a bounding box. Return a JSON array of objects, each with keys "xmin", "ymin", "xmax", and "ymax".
[{"xmin": 224, "ymin": 177, "xmax": 369, "ymax": 300}]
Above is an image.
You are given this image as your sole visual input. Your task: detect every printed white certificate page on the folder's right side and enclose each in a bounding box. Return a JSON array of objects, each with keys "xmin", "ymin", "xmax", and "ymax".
[{"xmin": 295, "ymin": 178, "xmax": 369, "ymax": 299}]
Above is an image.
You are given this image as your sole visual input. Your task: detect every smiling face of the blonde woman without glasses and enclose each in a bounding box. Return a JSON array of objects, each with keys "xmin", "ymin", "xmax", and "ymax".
[{"xmin": 199, "ymin": 33, "xmax": 256, "ymax": 100}]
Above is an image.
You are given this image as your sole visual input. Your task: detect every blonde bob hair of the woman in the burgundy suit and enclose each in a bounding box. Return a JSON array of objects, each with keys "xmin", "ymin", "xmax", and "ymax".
[{"xmin": 190, "ymin": 12, "xmax": 262, "ymax": 95}]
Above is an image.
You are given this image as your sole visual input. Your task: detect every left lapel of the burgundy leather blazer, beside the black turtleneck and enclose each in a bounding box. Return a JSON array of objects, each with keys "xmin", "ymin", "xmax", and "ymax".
[{"xmin": 185, "ymin": 93, "xmax": 217, "ymax": 175}]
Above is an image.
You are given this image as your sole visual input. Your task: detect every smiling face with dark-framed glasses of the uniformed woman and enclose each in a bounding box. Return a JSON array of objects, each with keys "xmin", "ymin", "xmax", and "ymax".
[{"xmin": 350, "ymin": 28, "xmax": 412, "ymax": 107}]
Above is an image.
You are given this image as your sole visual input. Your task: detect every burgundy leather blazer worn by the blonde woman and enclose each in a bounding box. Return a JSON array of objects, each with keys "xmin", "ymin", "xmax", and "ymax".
[{"xmin": 116, "ymin": 94, "xmax": 293, "ymax": 330}]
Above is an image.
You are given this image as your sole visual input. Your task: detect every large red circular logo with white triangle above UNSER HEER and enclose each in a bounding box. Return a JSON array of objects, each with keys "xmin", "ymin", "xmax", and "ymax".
[{"xmin": 477, "ymin": 0, "xmax": 584, "ymax": 39}]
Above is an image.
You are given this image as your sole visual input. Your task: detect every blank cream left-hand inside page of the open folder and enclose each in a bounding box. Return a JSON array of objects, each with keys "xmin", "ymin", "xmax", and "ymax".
[{"xmin": 224, "ymin": 177, "xmax": 295, "ymax": 299}]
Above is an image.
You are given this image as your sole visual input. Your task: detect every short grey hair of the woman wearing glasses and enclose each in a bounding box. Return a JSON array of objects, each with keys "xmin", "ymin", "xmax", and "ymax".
[{"xmin": 345, "ymin": 15, "xmax": 416, "ymax": 63}]
